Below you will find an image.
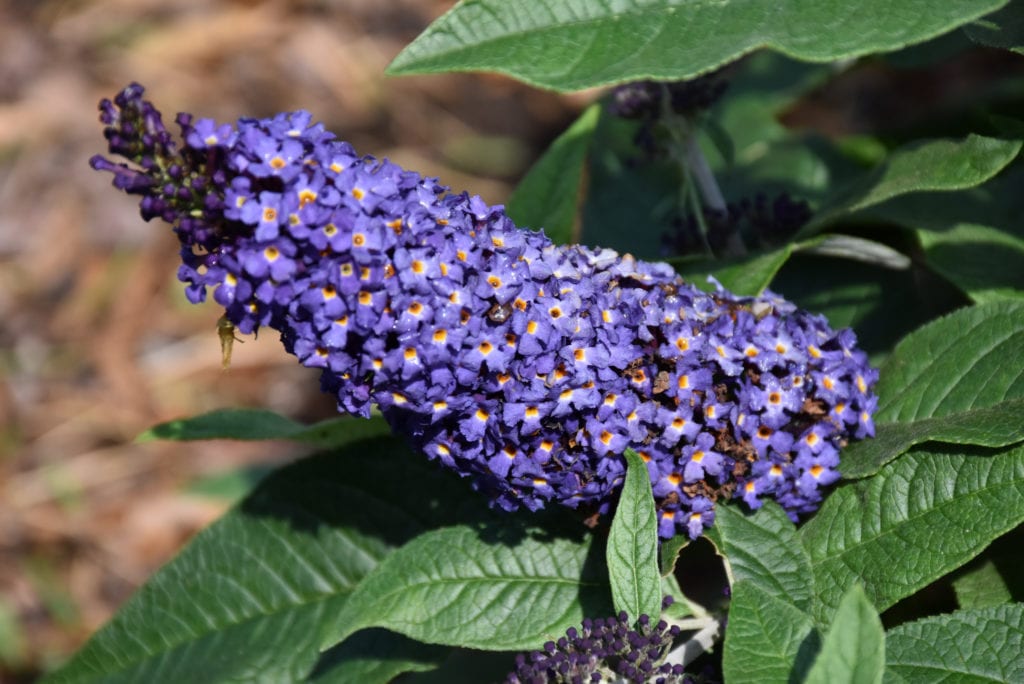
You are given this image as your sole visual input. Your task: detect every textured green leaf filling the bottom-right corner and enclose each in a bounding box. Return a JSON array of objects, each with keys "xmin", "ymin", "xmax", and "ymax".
[{"xmin": 886, "ymin": 603, "xmax": 1024, "ymax": 684}]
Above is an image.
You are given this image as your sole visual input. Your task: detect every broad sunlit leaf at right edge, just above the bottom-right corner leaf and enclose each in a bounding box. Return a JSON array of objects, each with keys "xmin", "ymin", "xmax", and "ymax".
[{"xmin": 798, "ymin": 445, "xmax": 1024, "ymax": 625}]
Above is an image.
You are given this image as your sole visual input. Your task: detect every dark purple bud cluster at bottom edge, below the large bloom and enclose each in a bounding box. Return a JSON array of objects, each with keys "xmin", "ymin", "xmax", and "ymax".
[{"xmin": 505, "ymin": 597, "xmax": 689, "ymax": 684}]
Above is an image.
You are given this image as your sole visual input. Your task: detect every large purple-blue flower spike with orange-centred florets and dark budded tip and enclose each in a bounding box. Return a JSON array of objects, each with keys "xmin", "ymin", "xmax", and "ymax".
[{"xmin": 91, "ymin": 84, "xmax": 877, "ymax": 538}]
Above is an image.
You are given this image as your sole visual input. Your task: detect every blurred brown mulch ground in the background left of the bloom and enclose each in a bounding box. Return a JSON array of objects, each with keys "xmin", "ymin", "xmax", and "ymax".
[{"xmin": 0, "ymin": 0, "xmax": 583, "ymax": 682}]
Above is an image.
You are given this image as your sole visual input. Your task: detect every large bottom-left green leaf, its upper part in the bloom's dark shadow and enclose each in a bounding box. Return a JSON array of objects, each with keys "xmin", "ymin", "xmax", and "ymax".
[{"xmin": 49, "ymin": 439, "xmax": 485, "ymax": 683}]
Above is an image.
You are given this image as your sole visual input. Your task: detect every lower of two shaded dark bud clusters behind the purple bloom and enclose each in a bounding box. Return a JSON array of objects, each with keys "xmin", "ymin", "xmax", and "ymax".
[{"xmin": 662, "ymin": 193, "xmax": 811, "ymax": 256}]
